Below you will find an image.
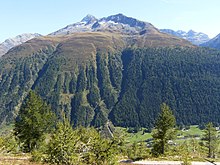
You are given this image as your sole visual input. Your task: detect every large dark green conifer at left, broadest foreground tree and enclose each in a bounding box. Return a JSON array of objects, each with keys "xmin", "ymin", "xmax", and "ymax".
[{"xmin": 14, "ymin": 91, "xmax": 55, "ymax": 152}]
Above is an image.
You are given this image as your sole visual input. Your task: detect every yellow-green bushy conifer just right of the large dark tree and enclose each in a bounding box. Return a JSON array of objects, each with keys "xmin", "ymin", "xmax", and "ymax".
[{"xmin": 46, "ymin": 117, "xmax": 81, "ymax": 165}]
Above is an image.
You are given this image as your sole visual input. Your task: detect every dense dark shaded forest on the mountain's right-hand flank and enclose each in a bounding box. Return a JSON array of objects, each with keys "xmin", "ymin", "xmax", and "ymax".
[{"xmin": 110, "ymin": 48, "xmax": 220, "ymax": 127}]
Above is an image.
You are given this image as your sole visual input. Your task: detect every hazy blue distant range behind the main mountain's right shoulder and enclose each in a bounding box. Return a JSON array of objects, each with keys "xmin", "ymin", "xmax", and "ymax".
[{"xmin": 160, "ymin": 29, "xmax": 210, "ymax": 45}]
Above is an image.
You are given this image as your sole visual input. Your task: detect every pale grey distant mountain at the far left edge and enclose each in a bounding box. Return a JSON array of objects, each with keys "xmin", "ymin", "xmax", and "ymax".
[{"xmin": 0, "ymin": 33, "xmax": 41, "ymax": 57}]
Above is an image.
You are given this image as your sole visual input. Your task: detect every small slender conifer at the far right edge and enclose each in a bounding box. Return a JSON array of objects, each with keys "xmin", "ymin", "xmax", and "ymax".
[{"xmin": 203, "ymin": 123, "xmax": 218, "ymax": 158}]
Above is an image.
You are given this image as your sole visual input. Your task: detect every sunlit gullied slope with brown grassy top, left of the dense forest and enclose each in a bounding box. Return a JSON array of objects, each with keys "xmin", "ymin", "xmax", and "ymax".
[{"xmin": 0, "ymin": 32, "xmax": 193, "ymax": 125}]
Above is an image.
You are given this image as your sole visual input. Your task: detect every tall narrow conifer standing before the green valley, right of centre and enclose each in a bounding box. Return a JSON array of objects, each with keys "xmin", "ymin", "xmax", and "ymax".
[{"xmin": 152, "ymin": 103, "xmax": 176, "ymax": 155}]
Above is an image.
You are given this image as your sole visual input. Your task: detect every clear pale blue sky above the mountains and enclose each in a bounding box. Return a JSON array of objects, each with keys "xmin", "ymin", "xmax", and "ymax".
[{"xmin": 0, "ymin": 0, "xmax": 220, "ymax": 42}]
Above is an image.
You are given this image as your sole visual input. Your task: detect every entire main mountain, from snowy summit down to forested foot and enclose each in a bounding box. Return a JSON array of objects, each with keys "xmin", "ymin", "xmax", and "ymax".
[{"xmin": 0, "ymin": 14, "xmax": 220, "ymax": 127}]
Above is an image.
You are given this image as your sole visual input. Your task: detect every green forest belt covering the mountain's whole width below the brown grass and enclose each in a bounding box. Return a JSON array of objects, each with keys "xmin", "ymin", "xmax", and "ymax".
[{"xmin": 0, "ymin": 45, "xmax": 220, "ymax": 127}]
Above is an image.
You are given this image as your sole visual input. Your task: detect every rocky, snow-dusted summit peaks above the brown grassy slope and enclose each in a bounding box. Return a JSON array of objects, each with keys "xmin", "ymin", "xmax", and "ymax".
[{"xmin": 49, "ymin": 14, "xmax": 158, "ymax": 35}]
